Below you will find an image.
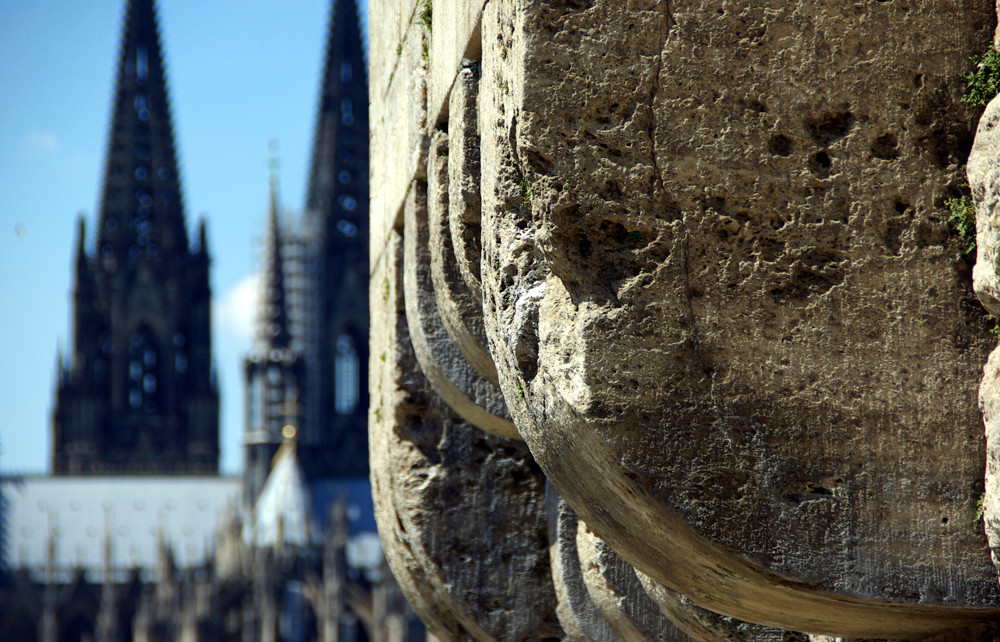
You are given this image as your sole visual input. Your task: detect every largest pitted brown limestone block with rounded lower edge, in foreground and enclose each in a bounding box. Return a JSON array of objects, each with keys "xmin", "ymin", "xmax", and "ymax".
[{"xmin": 480, "ymin": 0, "xmax": 1000, "ymax": 638}]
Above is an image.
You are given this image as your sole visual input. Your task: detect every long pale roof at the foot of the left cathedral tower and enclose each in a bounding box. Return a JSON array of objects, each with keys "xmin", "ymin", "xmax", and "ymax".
[{"xmin": 0, "ymin": 475, "xmax": 240, "ymax": 571}]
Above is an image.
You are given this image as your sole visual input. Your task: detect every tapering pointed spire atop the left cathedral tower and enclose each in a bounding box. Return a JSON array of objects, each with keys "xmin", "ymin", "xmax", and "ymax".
[{"xmin": 97, "ymin": 0, "xmax": 188, "ymax": 265}]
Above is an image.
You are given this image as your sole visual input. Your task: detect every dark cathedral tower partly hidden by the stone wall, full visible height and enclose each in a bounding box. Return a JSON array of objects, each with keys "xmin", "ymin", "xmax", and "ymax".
[{"xmin": 299, "ymin": 0, "xmax": 376, "ymax": 477}]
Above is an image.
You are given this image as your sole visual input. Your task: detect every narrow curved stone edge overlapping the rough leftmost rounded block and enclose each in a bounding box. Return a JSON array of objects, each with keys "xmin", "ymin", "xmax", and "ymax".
[{"xmin": 404, "ymin": 142, "xmax": 520, "ymax": 439}]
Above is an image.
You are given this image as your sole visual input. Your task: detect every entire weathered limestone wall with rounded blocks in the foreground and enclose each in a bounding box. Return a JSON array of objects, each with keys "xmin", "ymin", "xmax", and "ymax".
[{"xmin": 370, "ymin": 0, "xmax": 1000, "ymax": 640}]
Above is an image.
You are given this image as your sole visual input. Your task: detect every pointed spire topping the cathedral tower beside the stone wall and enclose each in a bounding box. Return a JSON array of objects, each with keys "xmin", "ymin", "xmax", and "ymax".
[{"xmin": 306, "ymin": 0, "xmax": 368, "ymax": 217}]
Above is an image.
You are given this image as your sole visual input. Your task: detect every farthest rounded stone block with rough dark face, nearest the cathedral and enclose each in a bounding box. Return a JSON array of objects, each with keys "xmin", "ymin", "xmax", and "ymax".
[{"xmin": 369, "ymin": 208, "xmax": 560, "ymax": 640}]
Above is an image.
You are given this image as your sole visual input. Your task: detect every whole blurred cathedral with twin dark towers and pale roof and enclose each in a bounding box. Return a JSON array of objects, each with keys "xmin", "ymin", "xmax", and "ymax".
[{"xmin": 0, "ymin": 0, "xmax": 424, "ymax": 642}]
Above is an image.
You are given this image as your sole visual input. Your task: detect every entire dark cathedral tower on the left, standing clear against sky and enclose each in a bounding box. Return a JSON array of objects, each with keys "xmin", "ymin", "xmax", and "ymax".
[{"xmin": 52, "ymin": 0, "xmax": 219, "ymax": 474}]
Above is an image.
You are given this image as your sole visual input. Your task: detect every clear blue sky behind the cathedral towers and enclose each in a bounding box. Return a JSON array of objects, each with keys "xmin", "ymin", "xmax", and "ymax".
[{"xmin": 0, "ymin": 0, "xmax": 368, "ymax": 473}]
